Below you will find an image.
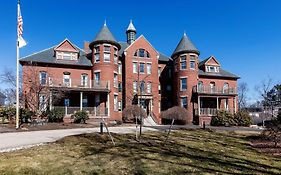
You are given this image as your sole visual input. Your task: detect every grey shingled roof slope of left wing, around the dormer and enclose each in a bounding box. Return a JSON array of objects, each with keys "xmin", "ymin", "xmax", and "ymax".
[{"xmin": 20, "ymin": 46, "xmax": 93, "ymax": 66}]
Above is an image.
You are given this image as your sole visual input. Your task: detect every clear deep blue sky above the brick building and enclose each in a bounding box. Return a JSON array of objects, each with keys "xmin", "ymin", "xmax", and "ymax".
[{"xmin": 0, "ymin": 0, "xmax": 281, "ymax": 103}]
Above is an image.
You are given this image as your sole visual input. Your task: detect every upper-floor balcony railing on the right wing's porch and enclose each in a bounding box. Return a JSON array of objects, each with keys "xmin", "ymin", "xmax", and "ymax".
[{"xmin": 193, "ymin": 86, "xmax": 237, "ymax": 95}]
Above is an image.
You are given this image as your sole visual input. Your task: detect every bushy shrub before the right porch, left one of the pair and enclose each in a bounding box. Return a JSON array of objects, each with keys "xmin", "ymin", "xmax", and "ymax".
[{"xmin": 211, "ymin": 111, "xmax": 236, "ymax": 126}]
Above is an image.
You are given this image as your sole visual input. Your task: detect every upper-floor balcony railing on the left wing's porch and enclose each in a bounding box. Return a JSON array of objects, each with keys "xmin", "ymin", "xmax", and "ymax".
[{"xmin": 46, "ymin": 77, "xmax": 110, "ymax": 90}]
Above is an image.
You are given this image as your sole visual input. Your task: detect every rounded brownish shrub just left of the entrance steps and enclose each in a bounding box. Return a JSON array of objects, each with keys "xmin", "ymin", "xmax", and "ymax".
[{"xmin": 122, "ymin": 105, "xmax": 147, "ymax": 123}]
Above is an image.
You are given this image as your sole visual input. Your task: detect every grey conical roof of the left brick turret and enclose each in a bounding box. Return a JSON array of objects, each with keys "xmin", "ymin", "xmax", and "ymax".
[{"xmin": 90, "ymin": 24, "xmax": 121, "ymax": 49}]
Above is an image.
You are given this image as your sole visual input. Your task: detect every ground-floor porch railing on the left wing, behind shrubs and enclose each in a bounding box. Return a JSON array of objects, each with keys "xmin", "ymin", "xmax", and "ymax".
[{"xmin": 53, "ymin": 106, "xmax": 109, "ymax": 117}]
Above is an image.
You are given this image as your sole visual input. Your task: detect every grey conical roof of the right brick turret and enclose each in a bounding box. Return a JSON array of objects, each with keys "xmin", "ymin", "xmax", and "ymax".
[{"xmin": 172, "ymin": 33, "xmax": 200, "ymax": 57}]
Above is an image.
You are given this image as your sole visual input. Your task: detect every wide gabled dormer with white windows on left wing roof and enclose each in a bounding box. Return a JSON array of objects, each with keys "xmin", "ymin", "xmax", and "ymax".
[{"xmin": 54, "ymin": 39, "xmax": 79, "ymax": 61}]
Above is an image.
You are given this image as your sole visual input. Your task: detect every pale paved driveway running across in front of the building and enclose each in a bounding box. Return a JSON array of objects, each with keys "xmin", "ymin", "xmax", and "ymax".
[{"xmin": 0, "ymin": 125, "xmax": 262, "ymax": 153}]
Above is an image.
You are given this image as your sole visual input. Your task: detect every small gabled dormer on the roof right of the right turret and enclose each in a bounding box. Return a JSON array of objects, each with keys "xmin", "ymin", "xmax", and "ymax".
[{"xmin": 199, "ymin": 56, "xmax": 220, "ymax": 73}]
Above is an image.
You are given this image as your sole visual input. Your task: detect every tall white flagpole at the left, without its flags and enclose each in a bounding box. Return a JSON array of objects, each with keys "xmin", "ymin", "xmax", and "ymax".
[{"xmin": 16, "ymin": 1, "xmax": 19, "ymax": 129}]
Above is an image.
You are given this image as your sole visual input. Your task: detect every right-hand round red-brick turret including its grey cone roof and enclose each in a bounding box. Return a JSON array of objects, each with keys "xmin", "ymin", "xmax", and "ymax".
[{"xmin": 171, "ymin": 33, "xmax": 200, "ymax": 124}]
